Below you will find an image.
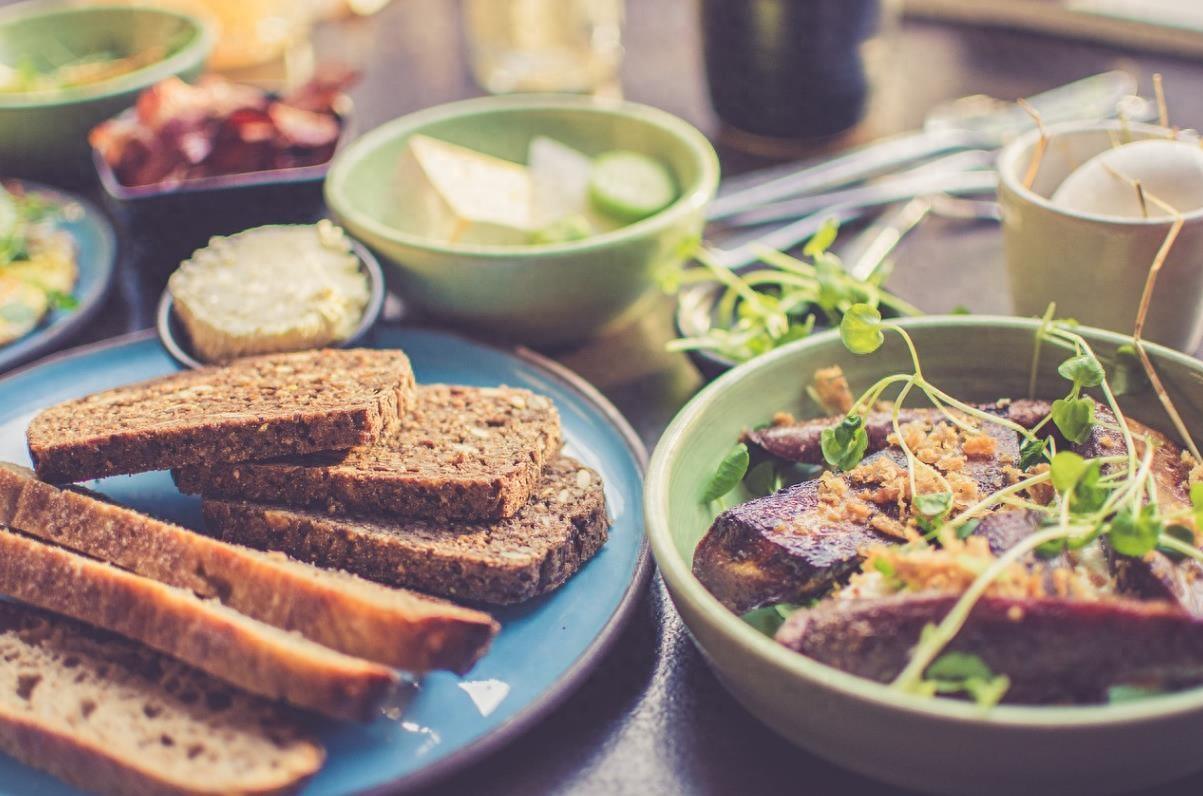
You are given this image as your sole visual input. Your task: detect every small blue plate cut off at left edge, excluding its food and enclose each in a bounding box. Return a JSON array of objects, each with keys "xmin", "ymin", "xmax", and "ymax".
[{"xmin": 0, "ymin": 179, "xmax": 117, "ymax": 373}]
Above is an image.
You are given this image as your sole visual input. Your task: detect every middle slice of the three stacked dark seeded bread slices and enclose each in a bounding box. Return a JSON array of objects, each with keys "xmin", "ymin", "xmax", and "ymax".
[{"xmin": 173, "ymin": 385, "xmax": 562, "ymax": 519}]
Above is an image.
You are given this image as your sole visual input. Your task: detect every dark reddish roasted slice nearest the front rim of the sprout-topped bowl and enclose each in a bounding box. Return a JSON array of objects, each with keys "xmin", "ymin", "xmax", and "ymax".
[{"xmin": 777, "ymin": 594, "xmax": 1203, "ymax": 703}]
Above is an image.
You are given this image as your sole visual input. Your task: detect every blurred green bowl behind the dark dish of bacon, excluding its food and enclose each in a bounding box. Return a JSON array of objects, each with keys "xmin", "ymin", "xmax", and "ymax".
[{"xmin": 0, "ymin": 0, "xmax": 213, "ymax": 182}]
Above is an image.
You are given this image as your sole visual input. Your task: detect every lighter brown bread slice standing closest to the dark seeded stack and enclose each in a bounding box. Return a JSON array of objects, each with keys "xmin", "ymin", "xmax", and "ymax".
[{"xmin": 0, "ymin": 462, "xmax": 498, "ymax": 673}]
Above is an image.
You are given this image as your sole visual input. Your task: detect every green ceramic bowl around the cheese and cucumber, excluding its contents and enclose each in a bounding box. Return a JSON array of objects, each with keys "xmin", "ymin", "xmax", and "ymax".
[{"xmin": 326, "ymin": 95, "xmax": 718, "ymax": 344}]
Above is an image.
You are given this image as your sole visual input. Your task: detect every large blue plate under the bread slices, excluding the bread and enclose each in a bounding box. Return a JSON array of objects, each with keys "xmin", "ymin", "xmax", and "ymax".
[{"xmin": 0, "ymin": 328, "xmax": 650, "ymax": 796}]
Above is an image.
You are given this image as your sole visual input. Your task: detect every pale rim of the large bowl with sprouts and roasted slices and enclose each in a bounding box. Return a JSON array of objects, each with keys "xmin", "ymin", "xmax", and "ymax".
[{"xmin": 644, "ymin": 315, "xmax": 1203, "ymax": 730}]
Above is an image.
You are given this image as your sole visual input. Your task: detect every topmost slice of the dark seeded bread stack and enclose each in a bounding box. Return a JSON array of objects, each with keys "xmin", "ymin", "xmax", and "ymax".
[{"xmin": 26, "ymin": 349, "xmax": 414, "ymax": 482}]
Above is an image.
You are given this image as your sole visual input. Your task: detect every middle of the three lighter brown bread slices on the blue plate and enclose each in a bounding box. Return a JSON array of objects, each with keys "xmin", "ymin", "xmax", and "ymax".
[{"xmin": 0, "ymin": 529, "xmax": 398, "ymax": 721}]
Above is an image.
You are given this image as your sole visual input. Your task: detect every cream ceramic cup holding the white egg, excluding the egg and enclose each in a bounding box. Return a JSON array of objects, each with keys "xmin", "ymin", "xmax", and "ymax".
[{"xmin": 998, "ymin": 121, "xmax": 1203, "ymax": 351}]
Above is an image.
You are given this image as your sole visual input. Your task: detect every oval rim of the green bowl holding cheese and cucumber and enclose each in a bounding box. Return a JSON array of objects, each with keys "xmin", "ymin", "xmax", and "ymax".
[{"xmin": 325, "ymin": 94, "xmax": 719, "ymax": 257}]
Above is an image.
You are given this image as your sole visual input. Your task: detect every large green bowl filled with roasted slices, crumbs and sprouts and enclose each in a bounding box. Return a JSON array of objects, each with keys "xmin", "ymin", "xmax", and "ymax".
[{"xmin": 645, "ymin": 317, "xmax": 1203, "ymax": 794}]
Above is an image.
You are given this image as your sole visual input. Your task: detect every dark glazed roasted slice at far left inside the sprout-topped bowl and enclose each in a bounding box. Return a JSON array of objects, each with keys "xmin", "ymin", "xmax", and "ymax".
[{"xmin": 693, "ymin": 452, "xmax": 903, "ymax": 613}]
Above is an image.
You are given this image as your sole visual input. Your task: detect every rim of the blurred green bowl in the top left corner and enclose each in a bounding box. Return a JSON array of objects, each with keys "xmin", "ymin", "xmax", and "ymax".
[{"xmin": 0, "ymin": 0, "xmax": 217, "ymax": 111}]
